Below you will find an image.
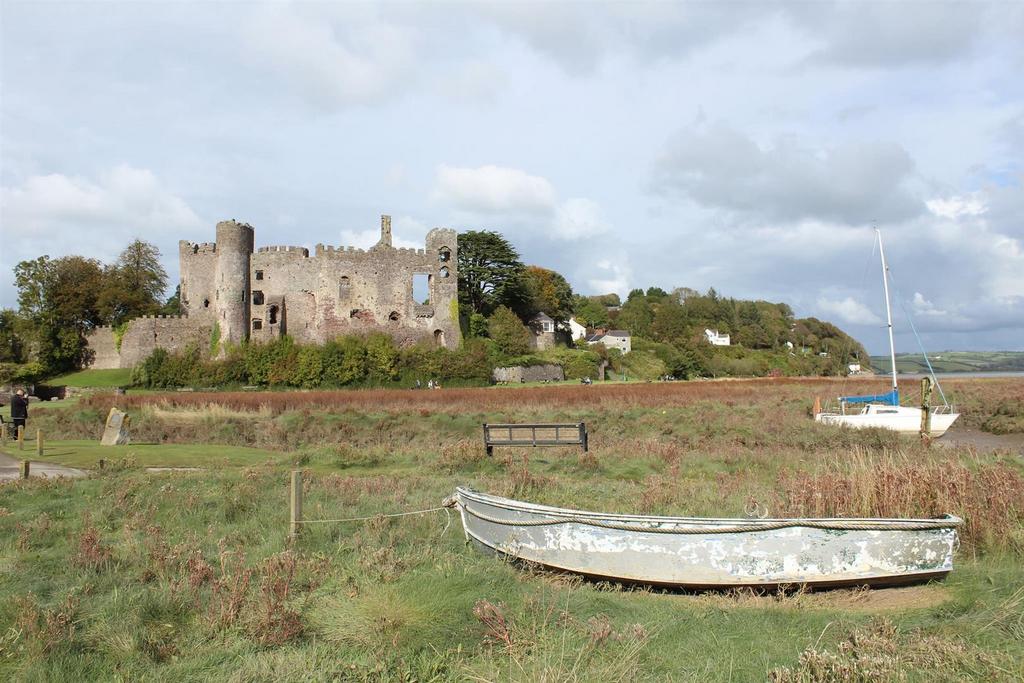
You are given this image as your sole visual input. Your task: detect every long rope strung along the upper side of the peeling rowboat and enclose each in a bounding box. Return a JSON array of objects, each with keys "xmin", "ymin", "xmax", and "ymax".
[{"xmin": 459, "ymin": 505, "xmax": 963, "ymax": 536}]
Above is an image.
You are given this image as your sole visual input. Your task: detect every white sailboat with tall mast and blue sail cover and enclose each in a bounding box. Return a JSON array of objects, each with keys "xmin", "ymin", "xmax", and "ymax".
[{"xmin": 814, "ymin": 228, "xmax": 959, "ymax": 438}]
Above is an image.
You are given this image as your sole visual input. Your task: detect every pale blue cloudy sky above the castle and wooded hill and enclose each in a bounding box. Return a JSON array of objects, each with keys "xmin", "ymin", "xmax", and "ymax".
[{"xmin": 0, "ymin": 0, "xmax": 1024, "ymax": 353}]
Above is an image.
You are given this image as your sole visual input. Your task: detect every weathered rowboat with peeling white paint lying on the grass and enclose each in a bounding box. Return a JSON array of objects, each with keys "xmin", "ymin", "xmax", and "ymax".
[{"xmin": 445, "ymin": 487, "xmax": 963, "ymax": 589}]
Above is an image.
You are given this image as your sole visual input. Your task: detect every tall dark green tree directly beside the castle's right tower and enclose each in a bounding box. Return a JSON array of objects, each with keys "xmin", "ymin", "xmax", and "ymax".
[{"xmin": 458, "ymin": 230, "xmax": 525, "ymax": 315}]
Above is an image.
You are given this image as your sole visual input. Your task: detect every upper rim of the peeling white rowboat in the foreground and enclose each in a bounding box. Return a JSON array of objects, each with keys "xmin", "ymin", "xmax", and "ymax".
[{"xmin": 456, "ymin": 486, "xmax": 964, "ymax": 532}]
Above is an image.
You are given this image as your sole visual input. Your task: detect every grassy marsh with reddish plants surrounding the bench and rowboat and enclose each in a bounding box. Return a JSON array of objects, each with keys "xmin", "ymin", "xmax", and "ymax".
[{"xmin": 0, "ymin": 380, "xmax": 1024, "ymax": 682}]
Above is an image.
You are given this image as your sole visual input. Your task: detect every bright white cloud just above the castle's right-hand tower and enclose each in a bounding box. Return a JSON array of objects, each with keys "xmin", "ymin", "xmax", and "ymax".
[{"xmin": 433, "ymin": 164, "xmax": 555, "ymax": 214}]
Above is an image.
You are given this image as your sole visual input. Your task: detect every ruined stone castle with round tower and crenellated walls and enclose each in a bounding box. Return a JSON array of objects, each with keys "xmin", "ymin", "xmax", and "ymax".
[{"xmin": 87, "ymin": 216, "xmax": 462, "ymax": 369}]
